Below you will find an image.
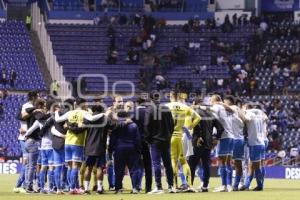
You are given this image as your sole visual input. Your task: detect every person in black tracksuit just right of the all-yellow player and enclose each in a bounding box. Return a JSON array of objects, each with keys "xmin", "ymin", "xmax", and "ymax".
[{"xmin": 188, "ymin": 106, "xmax": 224, "ymax": 192}]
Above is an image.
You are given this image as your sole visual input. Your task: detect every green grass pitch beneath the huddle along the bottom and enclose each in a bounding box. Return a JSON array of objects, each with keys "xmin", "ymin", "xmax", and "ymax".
[{"xmin": 0, "ymin": 175, "xmax": 300, "ymax": 200}]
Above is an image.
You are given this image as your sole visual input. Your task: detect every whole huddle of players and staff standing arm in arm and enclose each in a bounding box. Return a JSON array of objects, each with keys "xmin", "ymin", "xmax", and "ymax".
[{"xmin": 14, "ymin": 91, "xmax": 268, "ymax": 195}]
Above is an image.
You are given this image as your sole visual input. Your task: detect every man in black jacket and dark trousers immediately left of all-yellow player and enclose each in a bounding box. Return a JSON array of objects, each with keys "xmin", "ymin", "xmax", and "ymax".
[{"xmin": 144, "ymin": 95, "xmax": 174, "ymax": 192}]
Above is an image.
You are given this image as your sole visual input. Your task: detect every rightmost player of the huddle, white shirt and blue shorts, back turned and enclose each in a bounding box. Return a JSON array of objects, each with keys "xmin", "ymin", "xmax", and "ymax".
[{"xmin": 241, "ymin": 104, "xmax": 268, "ymax": 191}]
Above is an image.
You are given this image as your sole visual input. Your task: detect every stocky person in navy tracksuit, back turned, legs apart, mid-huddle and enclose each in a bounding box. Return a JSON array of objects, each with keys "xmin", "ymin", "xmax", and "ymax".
[{"xmin": 108, "ymin": 111, "xmax": 141, "ymax": 194}]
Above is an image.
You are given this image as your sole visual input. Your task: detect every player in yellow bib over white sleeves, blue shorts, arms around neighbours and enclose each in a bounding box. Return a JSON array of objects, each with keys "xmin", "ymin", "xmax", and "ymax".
[{"xmin": 55, "ymin": 98, "xmax": 104, "ymax": 194}]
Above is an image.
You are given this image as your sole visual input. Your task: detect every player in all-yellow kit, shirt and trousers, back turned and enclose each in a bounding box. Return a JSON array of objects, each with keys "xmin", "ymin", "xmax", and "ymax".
[{"xmin": 166, "ymin": 91, "xmax": 201, "ymax": 190}]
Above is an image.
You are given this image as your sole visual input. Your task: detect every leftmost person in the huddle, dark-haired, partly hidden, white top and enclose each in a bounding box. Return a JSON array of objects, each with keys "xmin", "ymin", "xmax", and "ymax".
[{"xmin": 13, "ymin": 91, "xmax": 38, "ymax": 193}]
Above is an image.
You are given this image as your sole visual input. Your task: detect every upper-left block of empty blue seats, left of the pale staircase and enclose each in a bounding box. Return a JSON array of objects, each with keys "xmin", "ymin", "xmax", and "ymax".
[{"xmin": 0, "ymin": 21, "xmax": 46, "ymax": 90}]
